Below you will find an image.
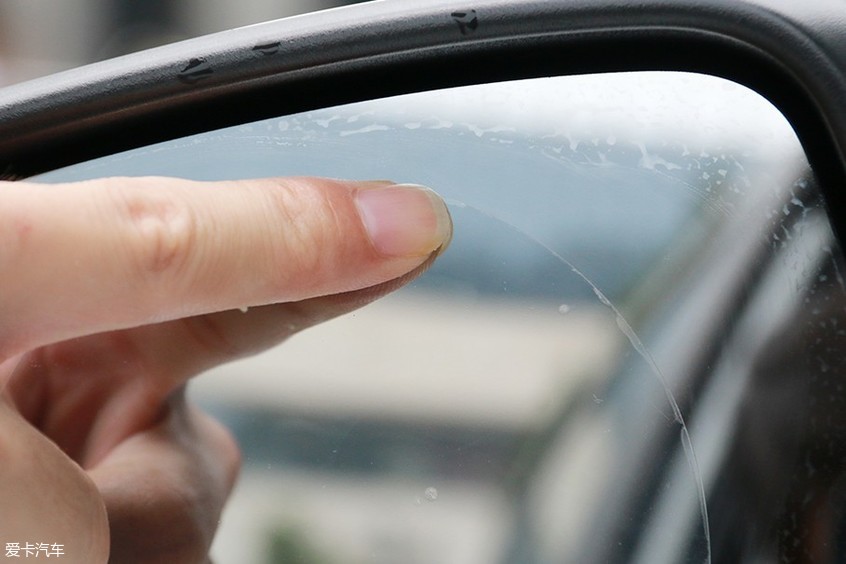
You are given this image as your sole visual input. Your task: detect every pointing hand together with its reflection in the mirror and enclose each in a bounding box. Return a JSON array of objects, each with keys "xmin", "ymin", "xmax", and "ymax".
[{"xmin": 0, "ymin": 178, "xmax": 451, "ymax": 563}]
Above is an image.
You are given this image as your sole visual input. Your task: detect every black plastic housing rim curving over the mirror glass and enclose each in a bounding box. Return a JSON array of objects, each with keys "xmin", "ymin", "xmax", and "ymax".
[{"xmin": 0, "ymin": 0, "xmax": 846, "ymax": 239}]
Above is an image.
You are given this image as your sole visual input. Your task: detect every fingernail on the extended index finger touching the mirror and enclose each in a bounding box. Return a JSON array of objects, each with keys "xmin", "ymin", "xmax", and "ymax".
[{"xmin": 355, "ymin": 184, "xmax": 452, "ymax": 257}]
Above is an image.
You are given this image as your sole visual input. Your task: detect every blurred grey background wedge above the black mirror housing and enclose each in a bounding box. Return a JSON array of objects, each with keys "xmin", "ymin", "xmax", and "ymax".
[{"xmin": 0, "ymin": 0, "xmax": 357, "ymax": 86}]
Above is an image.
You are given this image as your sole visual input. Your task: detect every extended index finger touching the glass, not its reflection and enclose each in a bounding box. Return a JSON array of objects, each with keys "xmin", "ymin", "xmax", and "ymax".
[{"xmin": 0, "ymin": 178, "xmax": 452, "ymax": 358}]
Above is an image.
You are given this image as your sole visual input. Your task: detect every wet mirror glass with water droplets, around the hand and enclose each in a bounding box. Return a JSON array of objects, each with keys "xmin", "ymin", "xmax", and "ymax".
[{"xmin": 42, "ymin": 73, "xmax": 846, "ymax": 564}]
